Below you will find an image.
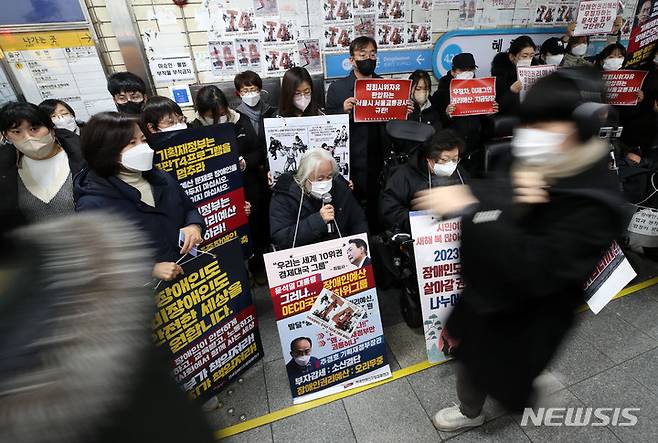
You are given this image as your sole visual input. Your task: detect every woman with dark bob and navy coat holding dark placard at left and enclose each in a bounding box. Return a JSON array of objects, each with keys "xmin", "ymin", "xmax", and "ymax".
[{"xmin": 74, "ymin": 112, "xmax": 205, "ymax": 281}]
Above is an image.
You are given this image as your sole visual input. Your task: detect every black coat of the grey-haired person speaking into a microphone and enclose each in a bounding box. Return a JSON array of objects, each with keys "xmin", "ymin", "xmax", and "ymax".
[{"xmin": 270, "ymin": 173, "xmax": 368, "ymax": 249}]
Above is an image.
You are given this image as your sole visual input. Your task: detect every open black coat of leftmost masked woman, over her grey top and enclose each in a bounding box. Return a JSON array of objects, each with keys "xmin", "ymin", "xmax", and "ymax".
[{"xmin": 0, "ymin": 128, "xmax": 85, "ymax": 232}]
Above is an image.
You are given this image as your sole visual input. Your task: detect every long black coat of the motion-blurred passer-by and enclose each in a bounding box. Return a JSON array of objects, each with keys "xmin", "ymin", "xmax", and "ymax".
[{"xmin": 447, "ymin": 158, "xmax": 623, "ymax": 410}]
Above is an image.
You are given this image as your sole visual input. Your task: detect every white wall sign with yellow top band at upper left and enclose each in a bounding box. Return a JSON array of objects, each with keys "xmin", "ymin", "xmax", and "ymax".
[{"xmin": 0, "ymin": 30, "xmax": 116, "ymax": 121}]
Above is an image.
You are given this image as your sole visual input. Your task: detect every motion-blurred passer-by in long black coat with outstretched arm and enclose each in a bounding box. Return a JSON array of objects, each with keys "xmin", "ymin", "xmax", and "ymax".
[{"xmin": 415, "ymin": 69, "xmax": 624, "ymax": 431}]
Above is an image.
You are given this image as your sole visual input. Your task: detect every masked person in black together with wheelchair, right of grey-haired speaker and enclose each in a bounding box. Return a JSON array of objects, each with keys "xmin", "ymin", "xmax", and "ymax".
[{"xmin": 378, "ymin": 129, "xmax": 468, "ymax": 328}]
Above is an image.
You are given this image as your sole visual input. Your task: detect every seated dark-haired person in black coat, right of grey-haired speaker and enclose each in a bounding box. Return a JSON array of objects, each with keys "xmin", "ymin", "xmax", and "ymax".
[{"xmin": 379, "ymin": 129, "xmax": 468, "ymax": 234}]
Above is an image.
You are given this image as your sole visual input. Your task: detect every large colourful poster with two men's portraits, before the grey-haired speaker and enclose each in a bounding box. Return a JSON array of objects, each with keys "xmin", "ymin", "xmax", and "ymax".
[{"xmin": 265, "ymin": 233, "xmax": 391, "ymax": 404}]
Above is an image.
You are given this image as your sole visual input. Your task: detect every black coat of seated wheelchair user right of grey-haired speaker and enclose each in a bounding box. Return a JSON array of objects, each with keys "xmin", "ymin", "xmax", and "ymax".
[{"xmin": 379, "ymin": 150, "xmax": 467, "ymax": 234}]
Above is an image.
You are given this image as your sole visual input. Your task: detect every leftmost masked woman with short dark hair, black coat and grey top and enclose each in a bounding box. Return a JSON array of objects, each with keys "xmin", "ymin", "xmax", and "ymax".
[{"xmin": 0, "ymin": 102, "xmax": 84, "ymax": 229}]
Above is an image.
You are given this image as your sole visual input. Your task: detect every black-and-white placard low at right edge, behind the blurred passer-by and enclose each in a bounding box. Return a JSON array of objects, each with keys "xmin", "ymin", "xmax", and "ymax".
[{"xmin": 585, "ymin": 242, "xmax": 637, "ymax": 314}]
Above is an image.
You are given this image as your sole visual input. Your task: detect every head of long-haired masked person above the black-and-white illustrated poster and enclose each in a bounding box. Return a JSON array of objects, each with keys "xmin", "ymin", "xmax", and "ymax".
[{"xmin": 279, "ymin": 66, "xmax": 322, "ymax": 117}]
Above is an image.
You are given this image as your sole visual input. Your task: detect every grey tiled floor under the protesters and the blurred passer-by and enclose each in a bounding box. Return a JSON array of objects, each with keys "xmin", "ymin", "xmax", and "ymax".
[{"xmin": 210, "ymin": 251, "xmax": 658, "ymax": 443}]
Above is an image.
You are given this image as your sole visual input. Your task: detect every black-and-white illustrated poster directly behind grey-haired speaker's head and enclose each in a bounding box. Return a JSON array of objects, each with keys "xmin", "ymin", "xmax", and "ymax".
[{"xmin": 264, "ymin": 114, "xmax": 350, "ymax": 181}]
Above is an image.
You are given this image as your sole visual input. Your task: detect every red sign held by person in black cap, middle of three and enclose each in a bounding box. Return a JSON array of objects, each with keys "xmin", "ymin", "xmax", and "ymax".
[{"xmin": 450, "ymin": 77, "xmax": 496, "ymax": 117}]
